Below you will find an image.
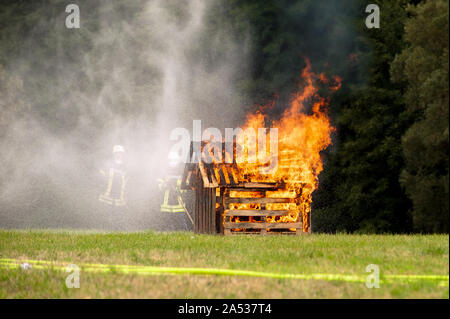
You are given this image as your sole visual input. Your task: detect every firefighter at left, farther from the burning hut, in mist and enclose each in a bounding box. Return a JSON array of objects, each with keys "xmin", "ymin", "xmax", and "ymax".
[{"xmin": 98, "ymin": 145, "xmax": 128, "ymax": 228}]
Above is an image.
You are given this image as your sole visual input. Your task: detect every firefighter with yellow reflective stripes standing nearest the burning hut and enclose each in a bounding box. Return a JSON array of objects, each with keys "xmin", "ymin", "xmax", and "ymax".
[{"xmin": 158, "ymin": 153, "xmax": 193, "ymax": 230}]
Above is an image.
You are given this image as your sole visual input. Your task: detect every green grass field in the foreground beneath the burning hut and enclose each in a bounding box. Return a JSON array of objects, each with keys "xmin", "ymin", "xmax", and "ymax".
[{"xmin": 0, "ymin": 231, "xmax": 449, "ymax": 298}]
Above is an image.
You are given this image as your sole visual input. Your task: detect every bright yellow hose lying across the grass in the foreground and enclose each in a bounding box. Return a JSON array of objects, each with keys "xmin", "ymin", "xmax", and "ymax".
[{"xmin": 0, "ymin": 258, "xmax": 449, "ymax": 287}]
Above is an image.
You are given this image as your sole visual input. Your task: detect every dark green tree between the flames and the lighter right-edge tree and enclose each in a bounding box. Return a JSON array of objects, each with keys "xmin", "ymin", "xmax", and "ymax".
[{"xmin": 312, "ymin": 1, "xmax": 412, "ymax": 233}]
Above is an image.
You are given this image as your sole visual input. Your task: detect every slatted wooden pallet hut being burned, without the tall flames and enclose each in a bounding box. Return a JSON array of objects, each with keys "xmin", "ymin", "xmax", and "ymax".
[{"xmin": 181, "ymin": 143, "xmax": 309, "ymax": 235}]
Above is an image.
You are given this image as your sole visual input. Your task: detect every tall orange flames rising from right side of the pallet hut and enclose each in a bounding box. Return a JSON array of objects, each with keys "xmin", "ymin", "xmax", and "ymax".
[{"xmin": 233, "ymin": 59, "xmax": 341, "ymax": 231}]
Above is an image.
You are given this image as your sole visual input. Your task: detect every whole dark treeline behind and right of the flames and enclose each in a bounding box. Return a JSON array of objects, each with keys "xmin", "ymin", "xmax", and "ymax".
[{"xmin": 221, "ymin": 0, "xmax": 449, "ymax": 233}]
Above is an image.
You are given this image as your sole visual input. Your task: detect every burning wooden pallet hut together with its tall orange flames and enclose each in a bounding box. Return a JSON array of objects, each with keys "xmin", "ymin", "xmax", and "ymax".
[{"xmin": 183, "ymin": 60, "xmax": 341, "ymax": 234}]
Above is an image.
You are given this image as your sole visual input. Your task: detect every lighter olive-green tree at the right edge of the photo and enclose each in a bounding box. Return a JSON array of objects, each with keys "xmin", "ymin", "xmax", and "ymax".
[{"xmin": 391, "ymin": 0, "xmax": 449, "ymax": 232}]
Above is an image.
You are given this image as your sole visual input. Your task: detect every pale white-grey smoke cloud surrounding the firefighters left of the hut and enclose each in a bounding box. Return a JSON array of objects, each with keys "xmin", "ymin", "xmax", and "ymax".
[{"xmin": 0, "ymin": 0, "xmax": 249, "ymax": 230}]
